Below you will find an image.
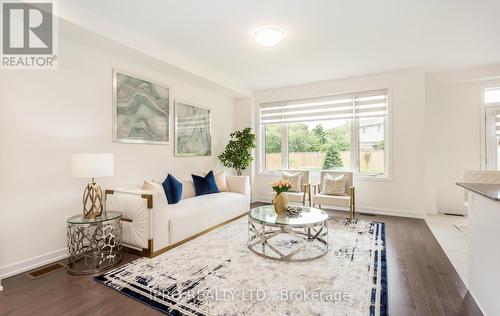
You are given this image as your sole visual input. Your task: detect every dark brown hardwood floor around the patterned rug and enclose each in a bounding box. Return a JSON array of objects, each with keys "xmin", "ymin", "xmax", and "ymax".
[{"xmin": 0, "ymin": 204, "xmax": 482, "ymax": 316}]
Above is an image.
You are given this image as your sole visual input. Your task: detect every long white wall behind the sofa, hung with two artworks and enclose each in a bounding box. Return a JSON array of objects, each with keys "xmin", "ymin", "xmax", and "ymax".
[{"xmin": 0, "ymin": 22, "xmax": 234, "ymax": 277}]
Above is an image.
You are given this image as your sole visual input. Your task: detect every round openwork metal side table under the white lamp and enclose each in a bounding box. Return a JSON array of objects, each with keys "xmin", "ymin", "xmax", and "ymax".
[{"xmin": 66, "ymin": 211, "xmax": 122, "ymax": 275}]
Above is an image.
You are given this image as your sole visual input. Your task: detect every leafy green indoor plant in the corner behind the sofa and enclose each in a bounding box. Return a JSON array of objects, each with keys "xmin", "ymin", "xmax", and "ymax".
[{"xmin": 219, "ymin": 127, "xmax": 257, "ymax": 176}]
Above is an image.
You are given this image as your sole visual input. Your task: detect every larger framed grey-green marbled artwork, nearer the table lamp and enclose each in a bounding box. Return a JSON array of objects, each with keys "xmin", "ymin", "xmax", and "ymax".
[{"xmin": 113, "ymin": 70, "xmax": 170, "ymax": 144}]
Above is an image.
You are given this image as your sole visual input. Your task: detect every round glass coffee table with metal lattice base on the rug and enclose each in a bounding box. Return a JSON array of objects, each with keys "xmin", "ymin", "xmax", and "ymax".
[{"xmin": 248, "ymin": 205, "xmax": 328, "ymax": 262}]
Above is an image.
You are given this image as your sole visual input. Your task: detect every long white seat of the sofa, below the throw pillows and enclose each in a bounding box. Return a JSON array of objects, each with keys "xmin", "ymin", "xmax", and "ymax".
[{"xmin": 168, "ymin": 192, "xmax": 246, "ymax": 244}]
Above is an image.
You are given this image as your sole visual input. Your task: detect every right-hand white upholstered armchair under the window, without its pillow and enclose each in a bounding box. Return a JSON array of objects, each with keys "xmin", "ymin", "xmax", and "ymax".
[{"xmin": 311, "ymin": 170, "xmax": 356, "ymax": 219}]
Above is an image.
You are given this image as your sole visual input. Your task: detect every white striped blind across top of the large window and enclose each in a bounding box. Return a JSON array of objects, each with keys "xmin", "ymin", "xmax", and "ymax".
[{"xmin": 260, "ymin": 90, "xmax": 388, "ymax": 124}]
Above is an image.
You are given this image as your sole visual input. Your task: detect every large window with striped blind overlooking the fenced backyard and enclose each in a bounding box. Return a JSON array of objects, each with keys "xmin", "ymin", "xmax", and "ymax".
[{"xmin": 260, "ymin": 90, "xmax": 388, "ymax": 176}]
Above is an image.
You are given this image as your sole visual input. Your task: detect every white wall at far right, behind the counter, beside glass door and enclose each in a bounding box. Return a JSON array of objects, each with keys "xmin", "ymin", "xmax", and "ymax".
[{"xmin": 426, "ymin": 66, "xmax": 500, "ymax": 213}]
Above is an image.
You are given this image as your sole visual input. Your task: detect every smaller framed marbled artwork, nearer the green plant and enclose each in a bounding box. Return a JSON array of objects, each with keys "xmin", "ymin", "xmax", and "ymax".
[{"xmin": 175, "ymin": 100, "xmax": 212, "ymax": 157}]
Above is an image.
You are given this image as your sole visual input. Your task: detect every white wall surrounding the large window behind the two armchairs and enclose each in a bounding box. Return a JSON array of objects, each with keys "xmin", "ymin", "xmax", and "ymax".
[{"xmin": 254, "ymin": 70, "xmax": 426, "ymax": 217}]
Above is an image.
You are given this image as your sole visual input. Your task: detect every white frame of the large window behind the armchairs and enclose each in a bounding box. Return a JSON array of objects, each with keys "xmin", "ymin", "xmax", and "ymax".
[{"xmin": 256, "ymin": 87, "xmax": 392, "ymax": 181}]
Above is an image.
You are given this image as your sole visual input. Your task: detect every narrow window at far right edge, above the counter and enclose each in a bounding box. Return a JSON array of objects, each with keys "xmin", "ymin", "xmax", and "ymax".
[{"xmin": 483, "ymin": 87, "xmax": 500, "ymax": 170}]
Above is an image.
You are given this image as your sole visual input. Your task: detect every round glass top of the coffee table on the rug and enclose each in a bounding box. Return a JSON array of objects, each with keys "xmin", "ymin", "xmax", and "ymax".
[{"xmin": 249, "ymin": 205, "xmax": 328, "ymax": 226}]
